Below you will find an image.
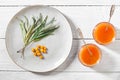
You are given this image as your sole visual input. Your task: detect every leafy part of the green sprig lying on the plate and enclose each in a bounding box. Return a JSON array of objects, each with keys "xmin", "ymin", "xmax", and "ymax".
[{"xmin": 18, "ymin": 13, "xmax": 59, "ymax": 57}]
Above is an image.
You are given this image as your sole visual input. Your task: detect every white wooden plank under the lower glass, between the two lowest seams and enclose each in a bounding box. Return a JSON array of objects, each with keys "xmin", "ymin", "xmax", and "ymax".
[{"xmin": 0, "ymin": 39, "xmax": 120, "ymax": 72}]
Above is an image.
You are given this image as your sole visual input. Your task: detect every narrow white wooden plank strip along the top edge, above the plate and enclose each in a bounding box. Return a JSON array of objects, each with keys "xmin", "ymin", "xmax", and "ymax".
[{"xmin": 0, "ymin": 0, "xmax": 120, "ymax": 5}]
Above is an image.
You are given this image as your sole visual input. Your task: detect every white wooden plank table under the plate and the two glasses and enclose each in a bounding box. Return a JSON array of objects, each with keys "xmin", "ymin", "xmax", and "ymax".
[{"xmin": 0, "ymin": 0, "xmax": 120, "ymax": 80}]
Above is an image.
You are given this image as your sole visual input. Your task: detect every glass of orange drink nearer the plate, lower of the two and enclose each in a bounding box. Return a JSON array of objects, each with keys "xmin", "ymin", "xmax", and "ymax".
[{"xmin": 78, "ymin": 44, "xmax": 101, "ymax": 67}]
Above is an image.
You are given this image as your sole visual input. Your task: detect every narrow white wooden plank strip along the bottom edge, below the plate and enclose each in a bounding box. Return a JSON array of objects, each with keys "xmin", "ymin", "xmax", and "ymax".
[{"xmin": 0, "ymin": 72, "xmax": 120, "ymax": 80}]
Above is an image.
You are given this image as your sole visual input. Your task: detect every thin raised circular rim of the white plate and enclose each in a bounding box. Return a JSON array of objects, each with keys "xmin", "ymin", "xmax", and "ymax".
[{"xmin": 5, "ymin": 5, "xmax": 73, "ymax": 73}]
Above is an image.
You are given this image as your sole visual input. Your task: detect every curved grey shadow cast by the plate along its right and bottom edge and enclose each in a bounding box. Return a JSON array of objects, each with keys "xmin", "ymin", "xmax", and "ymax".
[{"xmin": 33, "ymin": 16, "xmax": 79, "ymax": 76}]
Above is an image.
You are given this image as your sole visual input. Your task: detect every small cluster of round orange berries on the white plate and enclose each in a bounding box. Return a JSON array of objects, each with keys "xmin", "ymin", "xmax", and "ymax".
[{"xmin": 32, "ymin": 45, "xmax": 47, "ymax": 59}]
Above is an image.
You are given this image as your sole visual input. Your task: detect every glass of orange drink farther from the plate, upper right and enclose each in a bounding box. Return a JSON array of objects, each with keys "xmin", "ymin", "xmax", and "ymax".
[{"xmin": 93, "ymin": 22, "xmax": 116, "ymax": 45}]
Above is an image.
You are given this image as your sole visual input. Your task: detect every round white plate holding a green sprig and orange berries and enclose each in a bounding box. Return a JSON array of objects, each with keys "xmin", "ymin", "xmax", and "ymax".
[{"xmin": 6, "ymin": 5, "xmax": 72, "ymax": 72}]
